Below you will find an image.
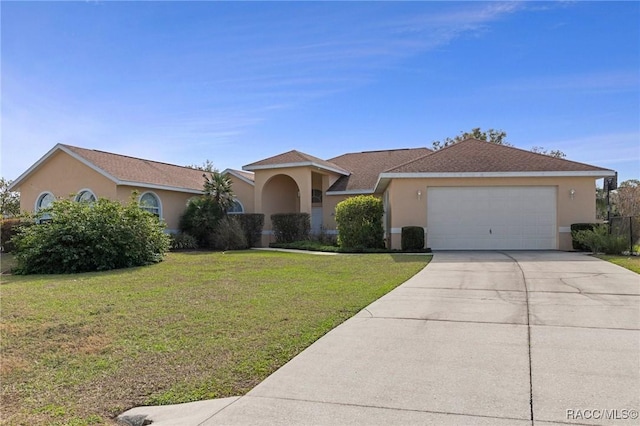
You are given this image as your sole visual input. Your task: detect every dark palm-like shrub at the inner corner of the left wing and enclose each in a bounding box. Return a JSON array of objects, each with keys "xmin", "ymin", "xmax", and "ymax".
[{"xmin": 179, "ymin": 196, "xmax": 224, "ymax": 247}]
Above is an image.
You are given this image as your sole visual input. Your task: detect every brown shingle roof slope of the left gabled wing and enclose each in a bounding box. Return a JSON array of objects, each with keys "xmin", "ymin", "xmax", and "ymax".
[{"xmin": 61, "ymin": 145, "xmax": 204, "ymax": 191}]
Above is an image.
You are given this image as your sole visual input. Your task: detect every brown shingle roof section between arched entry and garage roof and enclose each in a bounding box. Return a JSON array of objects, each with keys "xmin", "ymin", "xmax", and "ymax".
[{"xmin": 329, "ymin": 148, "xmax": 432, "ymax": 191}]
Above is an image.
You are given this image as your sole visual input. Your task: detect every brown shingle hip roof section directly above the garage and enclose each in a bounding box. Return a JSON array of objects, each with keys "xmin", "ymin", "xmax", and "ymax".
[{"xmin": 386, "ymin": 139, "xmax": 610, "ymax": 173}]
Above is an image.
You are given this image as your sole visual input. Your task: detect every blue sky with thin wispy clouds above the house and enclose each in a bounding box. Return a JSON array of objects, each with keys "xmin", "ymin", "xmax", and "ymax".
[{"xmin": 0, "ymin": 1, "xmax": 640, "ymax": 185}]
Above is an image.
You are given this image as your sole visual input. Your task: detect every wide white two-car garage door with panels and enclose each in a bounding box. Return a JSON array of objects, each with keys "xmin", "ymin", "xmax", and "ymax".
[{"xmin": 427, "ymin": 186, "xmax": 557, "ymax": 250}]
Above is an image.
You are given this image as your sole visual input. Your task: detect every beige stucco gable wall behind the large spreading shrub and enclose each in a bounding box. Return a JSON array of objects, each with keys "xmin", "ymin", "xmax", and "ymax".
[{"xmin": 19, "ymin": 151, "xmax": 116, "ymax": 212}]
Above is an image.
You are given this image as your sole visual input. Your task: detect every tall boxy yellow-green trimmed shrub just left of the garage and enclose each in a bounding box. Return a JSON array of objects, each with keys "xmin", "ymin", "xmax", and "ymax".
[{"xmin": 336, "ymin": 195, "xmax": 384, "ymax": 249}]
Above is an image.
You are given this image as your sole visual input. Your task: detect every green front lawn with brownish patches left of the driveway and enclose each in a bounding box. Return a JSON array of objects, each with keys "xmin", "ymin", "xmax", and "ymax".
[{"xmin": 0, "ymin": 251, "xmax": 430, "ymax": 425}]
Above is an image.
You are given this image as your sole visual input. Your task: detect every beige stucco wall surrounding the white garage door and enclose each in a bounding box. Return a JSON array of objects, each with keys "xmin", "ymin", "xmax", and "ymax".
[{"xmin": 388, "ymin": 177, "xmax": 596, "ymax": 250}]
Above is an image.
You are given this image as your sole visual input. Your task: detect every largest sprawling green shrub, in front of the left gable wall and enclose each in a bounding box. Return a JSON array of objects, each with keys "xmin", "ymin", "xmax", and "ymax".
[{"xmin": 13, "ymin": 197, "xmax": 169, "ymax": 274}]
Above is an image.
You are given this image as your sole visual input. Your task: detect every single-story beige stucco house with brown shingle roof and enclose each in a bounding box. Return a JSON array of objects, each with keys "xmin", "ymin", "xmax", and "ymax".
[{"xmin": 11, "ymin": 139, "xmax": 615, "ymax": 250}]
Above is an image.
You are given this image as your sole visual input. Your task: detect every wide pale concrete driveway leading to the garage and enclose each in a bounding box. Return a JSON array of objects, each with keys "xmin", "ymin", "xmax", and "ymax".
[{"xmin": 123, "ymin": 252, "xmax": 640, "ymax": 425}]
